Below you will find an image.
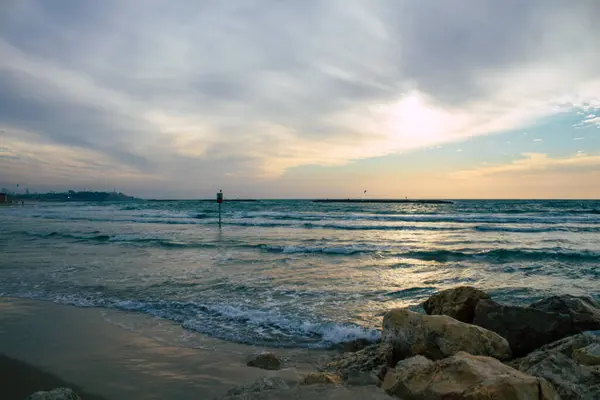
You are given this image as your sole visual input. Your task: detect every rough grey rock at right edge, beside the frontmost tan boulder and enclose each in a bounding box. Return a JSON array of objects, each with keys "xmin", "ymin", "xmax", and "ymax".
[{"xmin": 510, "ymin": 334, "xmax": 600, "ymax": 400}]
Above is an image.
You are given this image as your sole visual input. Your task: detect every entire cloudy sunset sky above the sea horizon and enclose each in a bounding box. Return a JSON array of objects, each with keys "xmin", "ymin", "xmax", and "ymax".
[{"xmin": 0, "ymin": 0, "xmax": 600, "ymax": 199}]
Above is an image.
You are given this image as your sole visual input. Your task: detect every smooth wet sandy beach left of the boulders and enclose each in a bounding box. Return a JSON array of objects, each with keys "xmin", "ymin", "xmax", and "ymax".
[{"xmin": 0, "ymin": 298, "xmax": 384, "ymax": 400}]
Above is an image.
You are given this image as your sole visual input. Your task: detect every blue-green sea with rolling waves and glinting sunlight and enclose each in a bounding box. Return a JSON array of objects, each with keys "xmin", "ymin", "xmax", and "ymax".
[{"xmin": 0, "ymin": 200, "xmax": 600, "ymax": 348}]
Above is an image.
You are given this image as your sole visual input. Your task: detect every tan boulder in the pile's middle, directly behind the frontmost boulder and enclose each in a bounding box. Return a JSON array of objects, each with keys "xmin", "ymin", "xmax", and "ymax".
[{"xmin": 382, "ymin": 308, "xmax": 511, "ymax": 361}]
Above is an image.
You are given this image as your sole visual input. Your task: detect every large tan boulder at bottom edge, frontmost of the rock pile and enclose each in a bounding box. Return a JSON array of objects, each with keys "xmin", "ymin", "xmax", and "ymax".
[{"xmin": 382, "ymin": 352, "xmax": 560, "ymax": 400}]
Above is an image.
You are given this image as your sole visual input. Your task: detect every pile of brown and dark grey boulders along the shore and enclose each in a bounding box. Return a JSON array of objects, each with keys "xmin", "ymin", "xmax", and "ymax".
[{"xmin": 25, "ymin": 287, "xmax": 600, "ymax": 400}]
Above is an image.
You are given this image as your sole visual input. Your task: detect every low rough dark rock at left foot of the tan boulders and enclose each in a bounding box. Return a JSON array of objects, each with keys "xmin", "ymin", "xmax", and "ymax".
[{"xmin": 322, "ymin": 343, "xmax": 393, "ymax": 380}]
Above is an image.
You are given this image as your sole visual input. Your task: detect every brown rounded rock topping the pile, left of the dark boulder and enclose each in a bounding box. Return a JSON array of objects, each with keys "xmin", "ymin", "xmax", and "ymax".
[{"xmin": 423, "ymin": 286, "xmax": 490, "ymax": 323}]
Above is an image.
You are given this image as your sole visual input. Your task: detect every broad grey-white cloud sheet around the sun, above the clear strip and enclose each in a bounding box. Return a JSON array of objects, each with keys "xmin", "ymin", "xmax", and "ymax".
[{"xmin": 0, "ymin": 0, "xmax": 600, "ymax": 194}]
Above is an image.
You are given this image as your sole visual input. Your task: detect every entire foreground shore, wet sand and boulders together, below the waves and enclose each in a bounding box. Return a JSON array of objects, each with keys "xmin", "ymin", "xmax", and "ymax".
[{"xmin": 0, "ymin": 286, "xmax": 600, "ymax": 400}]
